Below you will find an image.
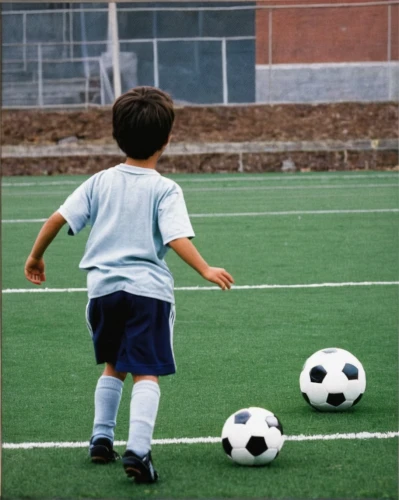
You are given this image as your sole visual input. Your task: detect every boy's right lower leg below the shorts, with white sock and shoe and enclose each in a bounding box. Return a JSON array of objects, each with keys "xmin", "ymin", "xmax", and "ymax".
[{"xmin": 122, "ymin": 375, "xmax": 161, "ymax": 483}]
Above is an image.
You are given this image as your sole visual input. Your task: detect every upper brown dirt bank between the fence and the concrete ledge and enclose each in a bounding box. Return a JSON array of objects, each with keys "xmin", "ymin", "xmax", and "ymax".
[{"xmin": 1, "ymin": 102, "xmax": 399, "ymax": 145}]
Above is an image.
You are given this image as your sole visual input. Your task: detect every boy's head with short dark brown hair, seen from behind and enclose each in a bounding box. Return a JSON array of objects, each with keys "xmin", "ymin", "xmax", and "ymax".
[{"xmin": 112, "ymin": 87, "xmax": 175, "ymax": 160}]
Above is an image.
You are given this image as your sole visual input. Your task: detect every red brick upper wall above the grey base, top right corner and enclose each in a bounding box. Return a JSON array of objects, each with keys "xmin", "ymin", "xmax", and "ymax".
[{"xmin": 256, "ymin": 0, "xmax": 399, "ymax": 65}]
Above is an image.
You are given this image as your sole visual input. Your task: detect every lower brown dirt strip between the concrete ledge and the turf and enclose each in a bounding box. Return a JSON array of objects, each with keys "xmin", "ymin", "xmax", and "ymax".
[{"xmin": 2, "ymin": 151, "xmax": 399, "ymax": 176}]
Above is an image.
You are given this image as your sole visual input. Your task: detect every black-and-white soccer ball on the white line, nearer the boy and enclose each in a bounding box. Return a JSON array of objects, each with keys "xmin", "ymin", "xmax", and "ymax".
[{"xmin": 222, "ymin": 407, "xmax": 284, "ymax": 465}]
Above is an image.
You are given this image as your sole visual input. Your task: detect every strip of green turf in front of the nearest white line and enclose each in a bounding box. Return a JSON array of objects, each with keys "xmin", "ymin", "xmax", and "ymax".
[{"xmin": 3, "ymin": 440, "xmax": 397, "ymax": 500}]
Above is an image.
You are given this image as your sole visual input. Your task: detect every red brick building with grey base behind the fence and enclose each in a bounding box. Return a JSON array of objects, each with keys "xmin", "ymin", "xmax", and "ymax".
[{"xmin": 256, "ymin": 0, "xmax": 399, "ymax": 102}]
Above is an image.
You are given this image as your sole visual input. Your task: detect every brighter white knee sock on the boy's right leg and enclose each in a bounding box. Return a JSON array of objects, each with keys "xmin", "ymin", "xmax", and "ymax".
[{"xmin": 126, "ymin": 380, "xmax": 161, "ymax": 457}]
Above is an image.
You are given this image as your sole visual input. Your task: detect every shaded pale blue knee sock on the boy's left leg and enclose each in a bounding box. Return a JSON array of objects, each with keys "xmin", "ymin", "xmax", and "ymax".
[{"xmin": 92, "ymin": 375, "xmax": 123, "ymax": 442}]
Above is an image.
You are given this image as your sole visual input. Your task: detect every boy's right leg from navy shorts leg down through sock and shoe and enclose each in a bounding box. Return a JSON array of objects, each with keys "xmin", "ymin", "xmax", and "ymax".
[{"xmin": 120, "ymin": 295, "xmax": 176, "ymax": 483}]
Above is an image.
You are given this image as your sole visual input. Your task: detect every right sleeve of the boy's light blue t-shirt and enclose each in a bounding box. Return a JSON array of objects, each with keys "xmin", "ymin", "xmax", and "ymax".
[{"xmin": 158, "ymin": 184, "xmax": 195, "ymax": 245}]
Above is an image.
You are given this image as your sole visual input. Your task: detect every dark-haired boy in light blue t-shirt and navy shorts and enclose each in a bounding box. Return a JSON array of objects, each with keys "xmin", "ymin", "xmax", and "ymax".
[{"xmin": 25, "ymin": 87, "xmax": 233, "ymax": 483}]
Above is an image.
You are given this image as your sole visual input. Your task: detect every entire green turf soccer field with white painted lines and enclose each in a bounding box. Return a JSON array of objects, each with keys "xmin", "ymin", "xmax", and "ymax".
[{"xmin": 2, "ymin": 172, "xmax": 399, "ymax": 499}]
